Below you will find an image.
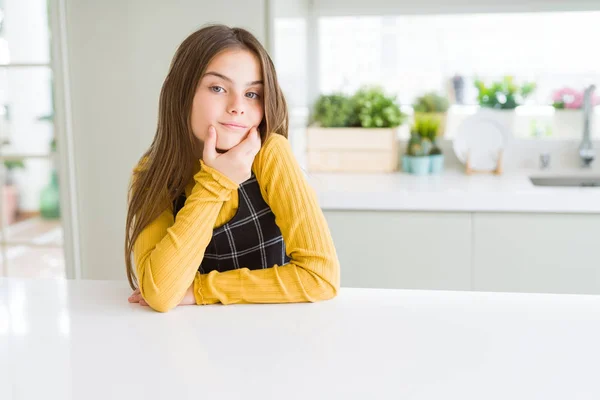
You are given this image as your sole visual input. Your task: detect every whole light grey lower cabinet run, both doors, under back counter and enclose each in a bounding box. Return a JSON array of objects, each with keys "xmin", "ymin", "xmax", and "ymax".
[{"xmin": 325, "ymin": 210, "xmax": 600, "ymax": 294}]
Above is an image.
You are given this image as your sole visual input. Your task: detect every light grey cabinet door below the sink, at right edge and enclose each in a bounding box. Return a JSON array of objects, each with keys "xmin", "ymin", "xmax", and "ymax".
[{"xmin": 473, "ymin": 213, "xmax": 600, "ymax": 294}]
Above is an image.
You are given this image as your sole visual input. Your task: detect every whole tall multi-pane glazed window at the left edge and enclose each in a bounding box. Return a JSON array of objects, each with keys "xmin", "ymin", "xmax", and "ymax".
[{"xmin": 0, "ymin": 0, "xmax": 65, "ymax": 278}]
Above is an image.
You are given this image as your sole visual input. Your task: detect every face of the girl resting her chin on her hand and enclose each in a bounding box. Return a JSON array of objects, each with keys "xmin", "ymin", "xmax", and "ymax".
[{"xmin": 191, "ymin": 49, "xmax": 264, "ymax": 152}]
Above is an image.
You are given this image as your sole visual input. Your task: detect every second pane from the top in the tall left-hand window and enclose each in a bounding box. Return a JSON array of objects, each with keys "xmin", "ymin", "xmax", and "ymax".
[{"xmin": 0, "ymin": 67, "xmax": 53, "ymax": 155}]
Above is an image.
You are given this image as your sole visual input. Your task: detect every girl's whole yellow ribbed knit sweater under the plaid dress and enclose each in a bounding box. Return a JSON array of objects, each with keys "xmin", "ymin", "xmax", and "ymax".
[{"xmin": 133, "ymin": 134, "xmax": 340, "ymax": 312}]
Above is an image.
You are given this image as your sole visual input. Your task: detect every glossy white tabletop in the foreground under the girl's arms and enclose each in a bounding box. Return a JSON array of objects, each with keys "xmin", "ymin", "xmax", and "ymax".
[{"xmin": 0, "ymin": 279, "xmax": 600, "ymax": 400}]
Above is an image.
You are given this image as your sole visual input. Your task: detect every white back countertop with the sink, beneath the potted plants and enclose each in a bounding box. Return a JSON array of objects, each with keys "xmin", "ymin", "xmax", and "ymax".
[{"xmin": 308, "ymin": 171, "xmax": 600, "ymax": 213}]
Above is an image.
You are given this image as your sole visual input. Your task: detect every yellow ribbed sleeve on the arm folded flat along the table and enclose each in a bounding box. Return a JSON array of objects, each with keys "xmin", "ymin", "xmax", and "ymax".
[{"xmin": 194, "ymin": 134, "xmax": 340, "ymax": 304}]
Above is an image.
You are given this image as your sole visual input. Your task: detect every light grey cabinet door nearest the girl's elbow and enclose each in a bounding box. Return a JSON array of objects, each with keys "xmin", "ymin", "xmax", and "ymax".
[{"xmin": 325, "ymin": 211, "xmax": 471, "ymax": 290}]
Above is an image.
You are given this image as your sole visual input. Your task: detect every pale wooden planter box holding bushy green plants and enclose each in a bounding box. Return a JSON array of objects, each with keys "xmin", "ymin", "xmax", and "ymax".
[{"xmin": 307, "ymin": 127, "xmax": 398, "ymax": 172}]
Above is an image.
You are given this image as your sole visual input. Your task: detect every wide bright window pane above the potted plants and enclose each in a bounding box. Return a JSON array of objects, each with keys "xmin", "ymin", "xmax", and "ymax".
[{"xmin": 319, "ymin": 11, "xmax": 600, "ymax": 104}]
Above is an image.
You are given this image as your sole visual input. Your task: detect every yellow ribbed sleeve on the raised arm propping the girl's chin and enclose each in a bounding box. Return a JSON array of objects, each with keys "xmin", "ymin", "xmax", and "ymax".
[{"xmin": 133, "ymin": 163, "xmax": 238, "ymax": 312}]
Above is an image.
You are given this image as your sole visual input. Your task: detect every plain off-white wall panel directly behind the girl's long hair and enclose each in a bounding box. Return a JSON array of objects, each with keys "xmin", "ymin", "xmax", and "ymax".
[{"xmin": 66, "ymin": 0, "xmax": 266, "ymax": 279}]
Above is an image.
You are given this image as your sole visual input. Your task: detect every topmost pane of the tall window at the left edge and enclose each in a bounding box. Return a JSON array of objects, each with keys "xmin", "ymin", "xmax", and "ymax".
[{"xmin": 0, "ymin": 0, "xmax": 50, "ymax": 64}]
